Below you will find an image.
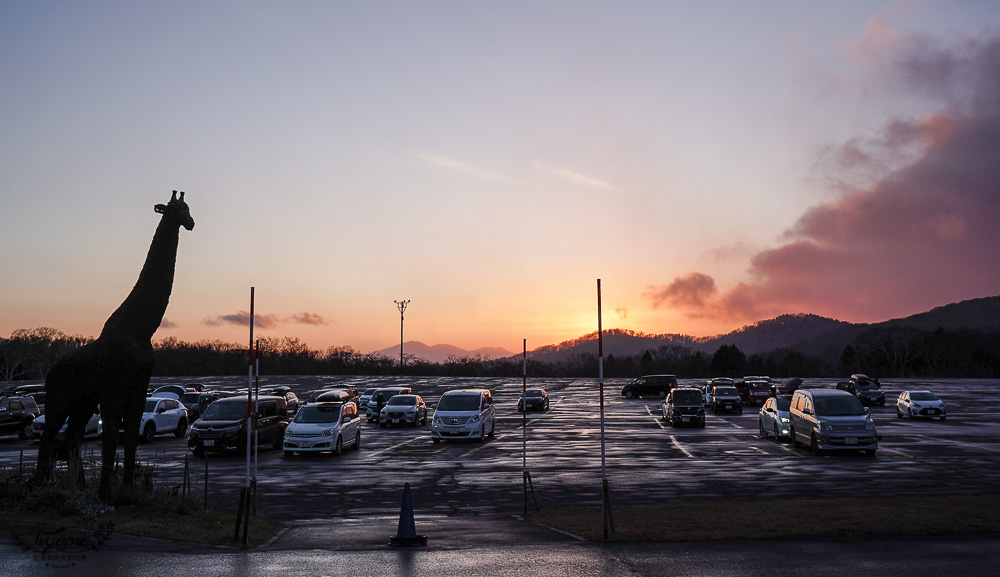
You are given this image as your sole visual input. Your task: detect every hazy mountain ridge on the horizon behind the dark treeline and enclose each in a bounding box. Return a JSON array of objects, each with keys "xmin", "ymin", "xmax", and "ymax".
[{"xmin": 376, "ymin": 296, "xmax": 1000, "ymax": 363}]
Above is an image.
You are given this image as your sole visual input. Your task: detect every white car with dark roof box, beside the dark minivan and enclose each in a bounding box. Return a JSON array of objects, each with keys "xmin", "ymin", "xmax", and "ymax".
[{"xmin": 282, "ymin": 401, "xmax": 361, "ymax": 457}]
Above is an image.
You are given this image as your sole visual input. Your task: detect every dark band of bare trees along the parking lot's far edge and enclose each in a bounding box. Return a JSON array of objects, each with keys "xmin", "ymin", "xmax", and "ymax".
[{"xmin": 0, "ymin": 327, "xmax": 1000, "ymax": 382}]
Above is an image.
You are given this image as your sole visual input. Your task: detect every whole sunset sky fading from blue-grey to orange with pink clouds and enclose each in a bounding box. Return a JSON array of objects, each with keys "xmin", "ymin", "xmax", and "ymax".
[{"xmin": 0, "ymin": 0, "xmax": 1000, "ymax": 352}]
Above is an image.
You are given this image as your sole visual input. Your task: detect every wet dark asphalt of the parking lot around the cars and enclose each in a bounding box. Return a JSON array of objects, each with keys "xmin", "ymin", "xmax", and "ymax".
[{"xmin": 0, "ymin": 377, "xmax": 1000, "ymax": 520}]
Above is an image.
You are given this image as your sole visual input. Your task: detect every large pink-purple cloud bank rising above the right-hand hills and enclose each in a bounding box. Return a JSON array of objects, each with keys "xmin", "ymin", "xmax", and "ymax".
[{"xmin": 646, "ymin": 32, "xmax": 1000, "ymax": 322}]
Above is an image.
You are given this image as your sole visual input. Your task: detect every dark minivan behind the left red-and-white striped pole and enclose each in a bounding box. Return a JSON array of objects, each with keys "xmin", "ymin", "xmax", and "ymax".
[{"xmin": 188, "ymin": 395, "xmax": 288, "ymax": 457}]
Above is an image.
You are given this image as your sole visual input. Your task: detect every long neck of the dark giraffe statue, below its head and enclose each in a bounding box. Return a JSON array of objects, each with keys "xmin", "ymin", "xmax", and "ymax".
[{"xmin": 101, "ymin": 218, "xmax": 179, "ymax": 341}]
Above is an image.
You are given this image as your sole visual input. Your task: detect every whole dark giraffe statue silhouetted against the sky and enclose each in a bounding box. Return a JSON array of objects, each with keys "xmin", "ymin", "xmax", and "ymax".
[{"xmin": 35, "ymin": 190, "xmax": 194, "ymax": 498}]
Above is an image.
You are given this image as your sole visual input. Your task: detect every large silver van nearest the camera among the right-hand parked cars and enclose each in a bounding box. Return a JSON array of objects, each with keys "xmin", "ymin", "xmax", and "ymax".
[{"xmin": 788, "ymin": 389, "xmax": 878, "ymax": 455}]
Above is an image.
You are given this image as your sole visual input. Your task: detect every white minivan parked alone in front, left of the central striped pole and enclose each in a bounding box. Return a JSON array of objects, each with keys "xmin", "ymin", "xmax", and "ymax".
[{"xmin": 431, "ymin": 389, "xmax": 496, "ymax": 443}]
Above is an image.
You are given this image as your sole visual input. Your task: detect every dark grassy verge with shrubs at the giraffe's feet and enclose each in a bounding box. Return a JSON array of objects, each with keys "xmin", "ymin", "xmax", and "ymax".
[{"xmin": 0, "ymin": 465, "xmax": 282, "ymax": 547}]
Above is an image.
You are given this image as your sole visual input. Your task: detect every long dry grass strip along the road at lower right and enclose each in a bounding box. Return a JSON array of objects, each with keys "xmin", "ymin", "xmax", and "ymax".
[{"xmin": 527, "ymin": 495, "xmax": 1000, "ymax": 542}]
